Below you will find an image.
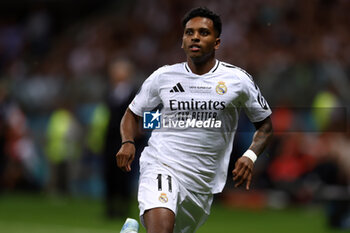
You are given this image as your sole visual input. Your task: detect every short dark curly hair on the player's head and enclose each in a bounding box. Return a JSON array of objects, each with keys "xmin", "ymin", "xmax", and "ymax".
[{"xmin": 182, "ymin": 7, "xmax": 222, "ymax": 37}]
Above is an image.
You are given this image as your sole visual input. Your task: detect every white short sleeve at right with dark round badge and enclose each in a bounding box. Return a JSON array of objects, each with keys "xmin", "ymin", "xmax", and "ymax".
[{"xmin": 241, "ymin": 73, "xmax": 272, "ymax": 122}]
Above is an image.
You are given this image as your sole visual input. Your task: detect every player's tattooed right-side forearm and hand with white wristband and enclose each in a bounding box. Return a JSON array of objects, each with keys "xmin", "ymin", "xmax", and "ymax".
[{"xmin": 232, "ymin": 117, "xmax": 273, "ymax": 190}]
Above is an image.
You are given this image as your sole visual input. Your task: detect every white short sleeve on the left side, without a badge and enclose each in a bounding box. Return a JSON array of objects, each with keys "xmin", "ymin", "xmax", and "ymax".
[{"xmin": 129, "ymin": 71, "xmax": 161, "ymax": 117}]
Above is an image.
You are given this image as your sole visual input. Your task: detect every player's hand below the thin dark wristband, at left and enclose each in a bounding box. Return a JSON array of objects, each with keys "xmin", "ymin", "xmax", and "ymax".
[{"xmin": 115, "ymin": 143, "xmax": 135, "ymax": 172}]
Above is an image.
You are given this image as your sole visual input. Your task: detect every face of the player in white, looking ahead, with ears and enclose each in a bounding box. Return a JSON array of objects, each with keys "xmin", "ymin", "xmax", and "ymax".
[{"xmin": 181, "ymin": 17, "xmax": 220, "ymax": 62}]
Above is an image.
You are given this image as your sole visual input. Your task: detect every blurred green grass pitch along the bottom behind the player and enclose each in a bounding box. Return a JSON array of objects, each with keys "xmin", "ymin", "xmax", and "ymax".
[{"xmin": 0, "ymin": 194, "xmax": 344, "ymax": 233}]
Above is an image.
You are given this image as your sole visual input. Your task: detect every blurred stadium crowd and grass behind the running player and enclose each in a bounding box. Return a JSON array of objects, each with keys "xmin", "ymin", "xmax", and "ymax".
[{"xmin": 0, "ymin": 0, "xmax": 350, "ymax": 233}]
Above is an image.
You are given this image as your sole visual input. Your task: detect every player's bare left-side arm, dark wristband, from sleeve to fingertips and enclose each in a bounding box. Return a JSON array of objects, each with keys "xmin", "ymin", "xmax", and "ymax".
[{"xmin": 116, "ymin": 108, "xmax": 140, "ymax": 172}]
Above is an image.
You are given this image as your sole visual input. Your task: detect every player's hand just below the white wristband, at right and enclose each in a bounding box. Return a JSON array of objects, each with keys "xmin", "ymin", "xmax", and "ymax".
[{"xmin": 232, "ymin": 156, "xmax": 254, "ymax": 190}]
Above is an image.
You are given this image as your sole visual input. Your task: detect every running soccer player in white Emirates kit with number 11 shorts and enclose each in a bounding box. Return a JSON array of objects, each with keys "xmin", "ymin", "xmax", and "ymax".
[{"xmin": 116, "ymin": 8, "xmax": 272, "ymax": 233}]
